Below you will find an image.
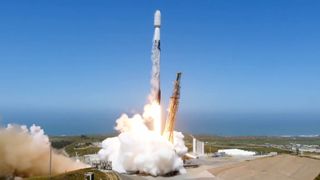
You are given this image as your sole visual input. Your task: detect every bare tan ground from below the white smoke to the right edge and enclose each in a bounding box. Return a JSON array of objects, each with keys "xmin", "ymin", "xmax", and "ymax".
[{"xmin": 120, "ymin": 155, "xmax": 320, "ymax": 180}]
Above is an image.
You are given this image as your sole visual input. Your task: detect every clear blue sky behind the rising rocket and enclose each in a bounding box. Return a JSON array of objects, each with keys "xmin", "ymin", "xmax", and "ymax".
[{"xmin": 0, "ymin": 0, "xmax": 320, "ymax": 134}]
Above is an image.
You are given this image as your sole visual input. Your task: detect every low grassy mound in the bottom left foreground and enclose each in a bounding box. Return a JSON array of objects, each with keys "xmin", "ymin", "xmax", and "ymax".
[{"xmin": 28, "ymin": 168, "xmax": 120, "ymax": 180}]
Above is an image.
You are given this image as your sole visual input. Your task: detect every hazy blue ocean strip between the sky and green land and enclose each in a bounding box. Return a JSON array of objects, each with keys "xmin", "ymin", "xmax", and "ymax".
[{"xmin": 0, "ymin": 109, "xmax": 320, "ymax": 136}]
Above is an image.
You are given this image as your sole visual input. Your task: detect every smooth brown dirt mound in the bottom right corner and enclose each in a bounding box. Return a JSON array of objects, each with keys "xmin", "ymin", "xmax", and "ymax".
[{"xmin": 208, "ymin": 155, "xmax": 320, "ymax": 180}]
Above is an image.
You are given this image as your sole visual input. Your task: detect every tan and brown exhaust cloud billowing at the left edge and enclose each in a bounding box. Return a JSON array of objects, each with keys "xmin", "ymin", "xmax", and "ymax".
[{"xmin": 0, "ymin": 124, "xmax": 86, "ymax": 177}]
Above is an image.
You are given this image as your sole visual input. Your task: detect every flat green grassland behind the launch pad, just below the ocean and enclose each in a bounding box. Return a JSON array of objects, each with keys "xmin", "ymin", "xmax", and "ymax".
[{"xmin": 50, "ymin": 135, "xmax": 320, "ymax": 156}]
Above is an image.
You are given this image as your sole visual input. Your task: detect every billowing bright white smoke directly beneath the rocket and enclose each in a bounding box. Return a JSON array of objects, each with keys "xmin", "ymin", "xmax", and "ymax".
[{"xmin": 98, "ymin": 114, "xmax": 187, "ymax": 176}]
